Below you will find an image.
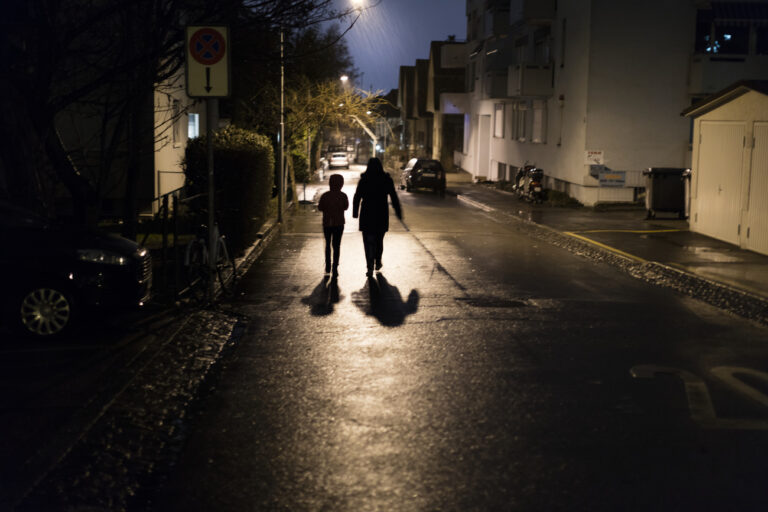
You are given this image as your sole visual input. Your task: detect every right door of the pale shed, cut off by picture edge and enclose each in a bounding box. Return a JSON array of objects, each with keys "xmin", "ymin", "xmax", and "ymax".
[{"xmin": 744, "ymin": 123, "xmax": 768, "ymax": 254}]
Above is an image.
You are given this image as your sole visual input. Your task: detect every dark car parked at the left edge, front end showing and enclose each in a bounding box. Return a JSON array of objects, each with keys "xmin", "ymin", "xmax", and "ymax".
[{"xmin": 0, "ymin": 202, "xmax": 152, "ymax": 337}]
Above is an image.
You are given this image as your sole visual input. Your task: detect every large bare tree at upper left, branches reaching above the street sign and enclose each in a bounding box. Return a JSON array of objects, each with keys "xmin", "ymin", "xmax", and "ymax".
[{"xmin": 0, "ymin": 0, "xmax": 360, "ymax": 236}]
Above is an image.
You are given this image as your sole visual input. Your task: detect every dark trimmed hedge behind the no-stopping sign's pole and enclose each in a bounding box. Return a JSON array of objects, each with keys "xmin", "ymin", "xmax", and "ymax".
[{"xmin": 183, "ymin": 126, "xmax": 275, "ymax": 254}]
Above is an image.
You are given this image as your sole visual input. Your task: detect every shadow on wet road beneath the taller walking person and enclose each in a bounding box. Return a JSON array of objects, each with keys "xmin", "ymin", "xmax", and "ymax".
[{"xmin": 352, "ymin": 274, "xmax": 419, "ymax": 327}]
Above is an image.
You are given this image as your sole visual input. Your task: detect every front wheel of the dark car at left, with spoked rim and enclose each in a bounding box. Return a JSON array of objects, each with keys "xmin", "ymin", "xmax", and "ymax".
[{"xmin": 18, "ymin": 285, "xmax": 74, "ymax": 337}]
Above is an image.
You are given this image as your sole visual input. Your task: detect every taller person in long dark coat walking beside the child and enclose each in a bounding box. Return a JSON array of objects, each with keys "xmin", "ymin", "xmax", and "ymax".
[{"xmin": 352, "ymin": 158, "xmax": 403, "ymax": 277}]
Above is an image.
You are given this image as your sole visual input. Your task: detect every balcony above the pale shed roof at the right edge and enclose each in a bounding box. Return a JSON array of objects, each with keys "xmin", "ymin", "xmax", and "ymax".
[{"xmin": 688, "ymin": 54, "xmax": 768, "ymax": 96}]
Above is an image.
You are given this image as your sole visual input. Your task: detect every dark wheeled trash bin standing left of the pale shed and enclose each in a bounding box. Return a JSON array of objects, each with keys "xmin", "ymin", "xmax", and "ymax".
[{"xmin": 643, "ymin": 167, "xmax": 691, "ymax": 219}]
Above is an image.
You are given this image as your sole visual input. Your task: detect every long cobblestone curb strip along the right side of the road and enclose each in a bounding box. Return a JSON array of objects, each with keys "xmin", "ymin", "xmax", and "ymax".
[{"xmin": 456, "ymin": 194, "xmax": 768, "ymax": 325}]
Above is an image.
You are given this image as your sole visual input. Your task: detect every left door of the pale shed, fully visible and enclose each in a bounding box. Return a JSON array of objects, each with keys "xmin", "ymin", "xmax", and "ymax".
[{"xmin": 695, "ymin": 121, "xmax": 745, "ymax": 245}]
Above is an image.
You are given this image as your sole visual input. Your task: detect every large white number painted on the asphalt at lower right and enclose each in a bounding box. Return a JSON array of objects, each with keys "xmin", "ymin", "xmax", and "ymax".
[{"xmin": 629, "ymin": 365, "xmax": 768, "ymax": 430}]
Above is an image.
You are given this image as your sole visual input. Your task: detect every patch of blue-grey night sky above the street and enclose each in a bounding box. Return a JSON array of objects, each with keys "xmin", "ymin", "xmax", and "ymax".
[{"xmin": 337, "ymin": 0, "xmax": 467, "ymax": 93}]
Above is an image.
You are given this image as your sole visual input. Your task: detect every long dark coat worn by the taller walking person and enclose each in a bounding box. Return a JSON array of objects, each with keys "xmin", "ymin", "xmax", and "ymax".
[{"xmin": 352, "ymin": 159, "xmax": 403, "ymax": 233}]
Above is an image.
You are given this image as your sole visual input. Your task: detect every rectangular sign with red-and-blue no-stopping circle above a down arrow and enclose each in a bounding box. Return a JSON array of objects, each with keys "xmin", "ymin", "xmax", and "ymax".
[{"xmin": 186, "ymin": 26, "xmax": 229, "ymax": 98}]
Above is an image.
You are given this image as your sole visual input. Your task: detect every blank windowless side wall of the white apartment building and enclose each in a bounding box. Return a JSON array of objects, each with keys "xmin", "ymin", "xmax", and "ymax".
[{"xmin": 586, "ymin": 0, "xmax": 696, "ymax": 174}]
